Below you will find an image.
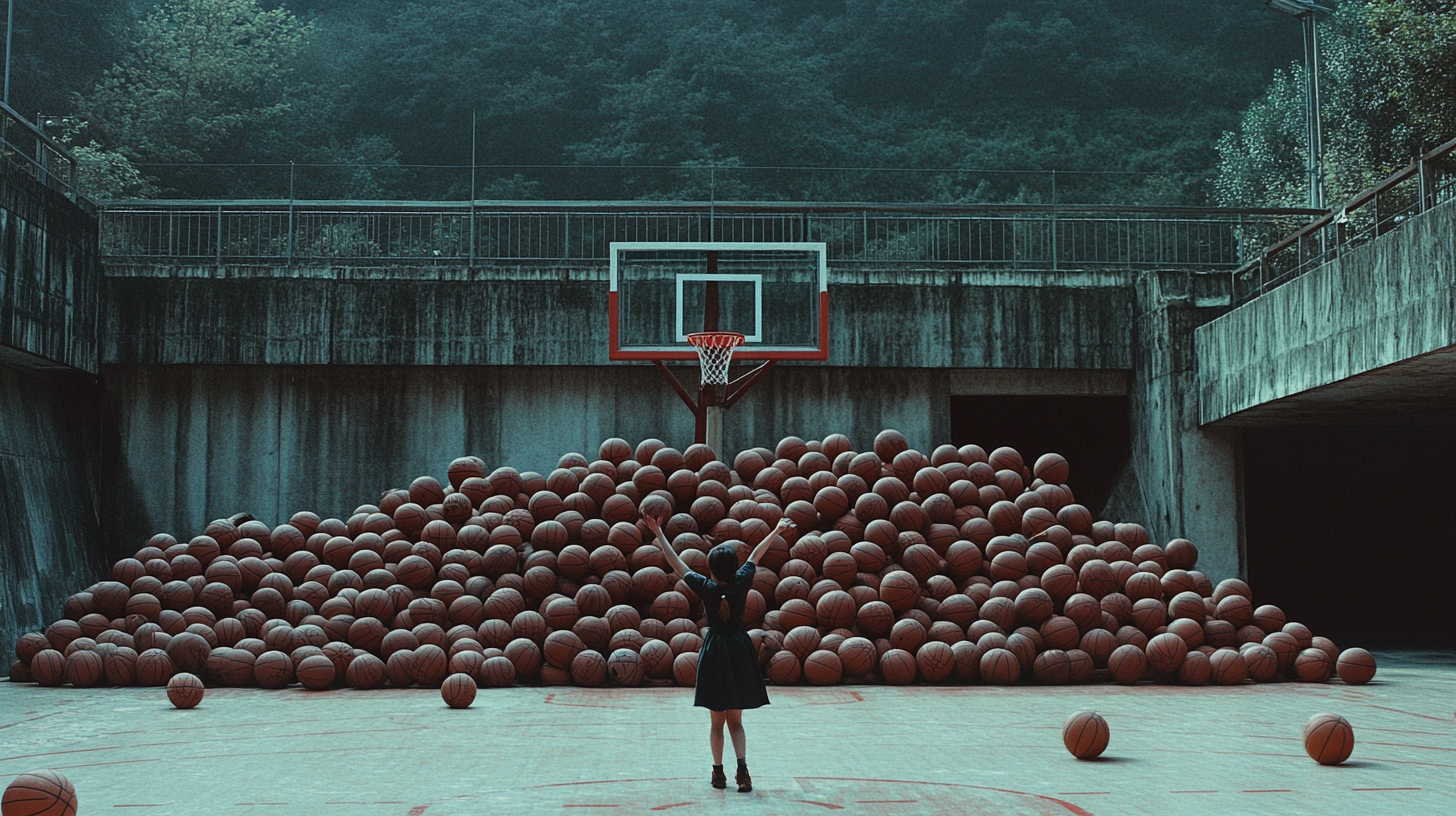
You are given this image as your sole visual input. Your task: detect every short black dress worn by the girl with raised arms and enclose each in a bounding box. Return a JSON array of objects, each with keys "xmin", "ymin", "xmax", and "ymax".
[{"xmin": 683, "ymin": 561, "xmax": 769, "ymax": 711}]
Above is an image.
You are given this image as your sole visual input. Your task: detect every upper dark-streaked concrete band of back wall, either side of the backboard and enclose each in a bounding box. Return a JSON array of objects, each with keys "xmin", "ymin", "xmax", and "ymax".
[{"xmin": 103, "ymin": 264, "xmax": 1135, "ymax": 370}]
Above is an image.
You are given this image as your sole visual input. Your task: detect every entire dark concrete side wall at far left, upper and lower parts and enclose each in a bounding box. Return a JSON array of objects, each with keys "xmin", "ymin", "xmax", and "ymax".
[{"xmin": 0, "ymin": 162, "xmax": 108, "ymax": 670}]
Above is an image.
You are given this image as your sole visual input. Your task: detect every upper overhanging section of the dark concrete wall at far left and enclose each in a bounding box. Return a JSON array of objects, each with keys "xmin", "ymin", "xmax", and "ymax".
[{"xmin": 0, "ymin": 162, "xmax": 100, "ymax": 373}]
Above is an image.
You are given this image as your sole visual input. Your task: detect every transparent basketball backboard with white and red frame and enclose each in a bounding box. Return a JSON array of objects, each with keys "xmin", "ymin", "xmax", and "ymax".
[{"xmin": 609, "ymin": 242, "xmax": 828, "ymax": 360}]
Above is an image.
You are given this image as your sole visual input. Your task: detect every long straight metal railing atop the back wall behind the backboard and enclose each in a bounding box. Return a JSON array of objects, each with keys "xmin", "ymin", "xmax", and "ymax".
[{"xmin": 102, "ymin": 201, "xmax": 1321, "ymax": 270}]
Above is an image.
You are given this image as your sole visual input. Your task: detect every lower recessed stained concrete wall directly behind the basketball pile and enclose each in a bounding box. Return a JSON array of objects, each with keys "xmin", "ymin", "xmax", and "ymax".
[{"xmin": 103, "ymin": 366, "xmax": 1007, "ymax": 548}]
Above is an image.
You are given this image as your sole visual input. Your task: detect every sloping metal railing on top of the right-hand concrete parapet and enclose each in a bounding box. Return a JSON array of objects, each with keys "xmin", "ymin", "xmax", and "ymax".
[{"xmin": 1233, "ymin": 138, "xmax": 1456, "ymax": 303}]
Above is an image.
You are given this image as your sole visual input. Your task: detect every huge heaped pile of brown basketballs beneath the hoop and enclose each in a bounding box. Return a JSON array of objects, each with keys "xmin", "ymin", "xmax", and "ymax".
[{"xmin": 10, "ymin": 430, "xmax": 1374, "ymax": 705}]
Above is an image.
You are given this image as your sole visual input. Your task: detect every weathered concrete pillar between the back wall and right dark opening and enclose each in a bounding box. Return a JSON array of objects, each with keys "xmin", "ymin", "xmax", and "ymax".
[{"xmin": 1131, "ymin": 272, "xmax": 1246, "ymax": 583}]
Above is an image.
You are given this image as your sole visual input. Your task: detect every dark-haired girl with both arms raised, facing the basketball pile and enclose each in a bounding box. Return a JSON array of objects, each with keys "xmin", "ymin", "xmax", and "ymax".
[{"xmin": 646, "ymin": 516, "xmax": 792, "ymax": 793}]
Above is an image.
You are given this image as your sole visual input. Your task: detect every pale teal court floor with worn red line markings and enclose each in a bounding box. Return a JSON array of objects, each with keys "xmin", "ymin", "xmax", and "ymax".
[{"xmin": 0, "ymin": 653, "xmax": 1456, "ymax": 816}]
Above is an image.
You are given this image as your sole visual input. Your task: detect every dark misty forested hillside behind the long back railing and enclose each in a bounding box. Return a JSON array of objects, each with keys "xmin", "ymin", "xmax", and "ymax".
[{"xmin": 16, "ymin": 0, "xmax": 1333, "ymax": 203}]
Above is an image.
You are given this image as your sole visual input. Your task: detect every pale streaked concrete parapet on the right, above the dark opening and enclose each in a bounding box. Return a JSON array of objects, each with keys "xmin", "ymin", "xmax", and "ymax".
[{"xmin": 1194, "ymin": 201, "xmax": 1456, "ymax": 424}]
